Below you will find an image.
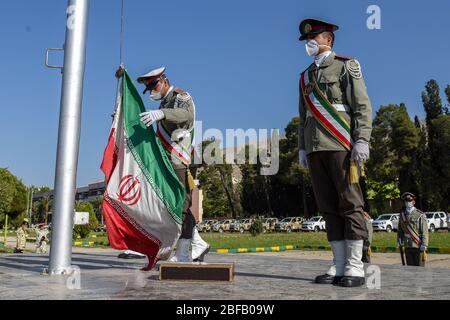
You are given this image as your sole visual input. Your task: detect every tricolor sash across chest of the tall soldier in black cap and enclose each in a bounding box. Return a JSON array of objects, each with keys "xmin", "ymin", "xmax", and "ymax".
[{"xmin": 300, "ymin": 71, "xmax": 353, "ymax": 151}]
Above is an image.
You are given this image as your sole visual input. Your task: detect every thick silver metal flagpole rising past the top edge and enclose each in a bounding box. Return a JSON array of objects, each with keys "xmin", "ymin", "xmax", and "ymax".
[{"xmin": 49, "ymin": 0, "xmax": 89, "ymax": 275}]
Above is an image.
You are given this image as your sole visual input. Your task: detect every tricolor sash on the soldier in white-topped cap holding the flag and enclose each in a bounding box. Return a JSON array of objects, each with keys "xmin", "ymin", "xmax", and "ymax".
[{"xmin": 157, "ymin": 121, "xmax": 194, "ymax": 166}]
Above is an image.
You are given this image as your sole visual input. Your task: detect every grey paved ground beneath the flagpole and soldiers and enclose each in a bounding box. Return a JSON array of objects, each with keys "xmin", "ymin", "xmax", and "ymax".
[{"xmin": 0, "ymin": 248, "xmax": 450, "ymax": 300}]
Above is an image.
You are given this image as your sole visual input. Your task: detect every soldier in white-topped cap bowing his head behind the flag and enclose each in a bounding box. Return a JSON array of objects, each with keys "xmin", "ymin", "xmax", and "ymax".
[{"xmin": 138, "ymin": 68, "xmax": 209, "ymax": 262}]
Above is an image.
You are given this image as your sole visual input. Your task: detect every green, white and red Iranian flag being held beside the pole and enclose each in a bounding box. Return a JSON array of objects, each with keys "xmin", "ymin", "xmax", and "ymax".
[{"xmin": 101, "ymin": 72, "xmax": 185, "ymax": 270}]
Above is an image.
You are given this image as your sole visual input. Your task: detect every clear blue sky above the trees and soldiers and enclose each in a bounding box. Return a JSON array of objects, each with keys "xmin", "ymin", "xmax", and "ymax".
[{"xmin": 0, "ymin": 0, "xmax": 450, "ymax": 187}]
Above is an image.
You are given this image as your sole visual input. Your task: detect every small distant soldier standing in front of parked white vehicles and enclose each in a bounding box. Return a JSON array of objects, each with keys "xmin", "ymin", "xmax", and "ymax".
[{"xmin": 397, "ymin": 192, "xmax": 428, "ymax": 267}]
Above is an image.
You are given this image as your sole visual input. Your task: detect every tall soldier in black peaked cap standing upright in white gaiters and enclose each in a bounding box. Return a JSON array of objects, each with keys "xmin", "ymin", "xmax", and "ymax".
[{"xmin": 299, "ymin": 19, "xmax": 372, "ymax": 287}]
